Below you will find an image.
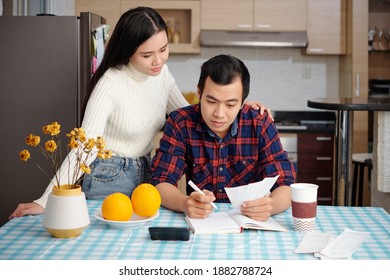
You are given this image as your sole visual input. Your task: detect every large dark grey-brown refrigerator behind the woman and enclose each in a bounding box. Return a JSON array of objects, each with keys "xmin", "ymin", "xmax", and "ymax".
[{"xmin": 0, "ymin": 13, "xmax": 106, "ymax": 225}]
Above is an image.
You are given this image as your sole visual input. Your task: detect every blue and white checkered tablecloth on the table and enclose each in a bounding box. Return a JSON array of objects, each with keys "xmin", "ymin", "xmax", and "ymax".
[{"xmin": 0, "ymin": 201, "xmax": 390, "ymax": 260}]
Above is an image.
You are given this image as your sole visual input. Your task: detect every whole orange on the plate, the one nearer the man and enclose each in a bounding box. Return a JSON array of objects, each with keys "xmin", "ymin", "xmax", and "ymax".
[{"xmin": 131, "ymin": 183, "xmax": 161, "ymax": 217}]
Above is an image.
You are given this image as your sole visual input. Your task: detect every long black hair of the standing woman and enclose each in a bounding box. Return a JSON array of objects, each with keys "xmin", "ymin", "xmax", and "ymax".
[{"xmin": 83, "ymin": 7, "xmax": 167, "ymax": 115}]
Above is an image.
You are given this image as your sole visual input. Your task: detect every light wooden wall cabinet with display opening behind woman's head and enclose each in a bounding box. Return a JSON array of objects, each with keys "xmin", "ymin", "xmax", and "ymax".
[{"xmin": 120, "ymin": 0, "xmax": 200, "ymax": 53}]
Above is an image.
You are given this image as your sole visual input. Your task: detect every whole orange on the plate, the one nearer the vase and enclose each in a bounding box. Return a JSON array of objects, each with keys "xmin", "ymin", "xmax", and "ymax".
[{"xmin": 102, "ymin": 192, "xmax": 133, "ymax": 221}]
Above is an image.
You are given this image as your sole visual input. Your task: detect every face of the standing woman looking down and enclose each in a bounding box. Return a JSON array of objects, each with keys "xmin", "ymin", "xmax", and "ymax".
[{"xmin": 130, "ymin": 30, "xmax": 169, "ymax": 76}]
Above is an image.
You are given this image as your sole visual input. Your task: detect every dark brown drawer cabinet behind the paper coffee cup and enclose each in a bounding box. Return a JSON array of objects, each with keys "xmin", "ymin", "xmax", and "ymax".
[{"xmin": 297, "ymin": 133, "xmax": 334, "ymax": 205}]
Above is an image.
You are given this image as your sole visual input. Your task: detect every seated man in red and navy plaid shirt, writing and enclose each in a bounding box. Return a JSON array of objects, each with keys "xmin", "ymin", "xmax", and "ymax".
[{"xmin": 151, "ymin": 55, "xmax": 295, "ymax": 221}]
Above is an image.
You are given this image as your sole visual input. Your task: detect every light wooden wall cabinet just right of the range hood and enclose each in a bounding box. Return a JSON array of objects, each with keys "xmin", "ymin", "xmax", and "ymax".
[{"xmin": 306, "ymin": 0, "xmax": 347, "ymax": 55}]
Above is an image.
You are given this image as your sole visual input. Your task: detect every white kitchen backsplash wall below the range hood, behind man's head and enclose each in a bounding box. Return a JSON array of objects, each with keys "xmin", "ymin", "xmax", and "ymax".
[{"xmin": 167, "ymin": 48, "xmax": 339, "ymax": 111}]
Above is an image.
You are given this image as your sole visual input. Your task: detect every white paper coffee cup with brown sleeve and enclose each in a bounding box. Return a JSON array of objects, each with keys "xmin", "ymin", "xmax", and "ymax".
[{"xmin": 290, "ymin": 183, "xmax": 318, "ymax": 232}]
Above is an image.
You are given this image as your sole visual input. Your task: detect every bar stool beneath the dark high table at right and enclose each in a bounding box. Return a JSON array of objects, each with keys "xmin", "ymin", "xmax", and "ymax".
[{"xmin": 351, "ymin": 153, "xmax": 372, "ymax": 206}]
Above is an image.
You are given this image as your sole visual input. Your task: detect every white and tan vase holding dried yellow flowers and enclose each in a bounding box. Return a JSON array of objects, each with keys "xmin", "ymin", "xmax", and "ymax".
[{"xmin": 42, "ymin": 185, "xmax": 90, "ymax": 238}]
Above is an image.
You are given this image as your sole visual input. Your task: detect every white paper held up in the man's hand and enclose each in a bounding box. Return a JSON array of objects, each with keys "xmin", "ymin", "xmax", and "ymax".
[{"xmin": 225, "ymin": 175, "xmax": 279, "ymax": 208}]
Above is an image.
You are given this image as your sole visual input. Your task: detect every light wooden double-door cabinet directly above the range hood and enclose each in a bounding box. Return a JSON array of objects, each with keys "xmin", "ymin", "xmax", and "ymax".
[{"xmin": 201, "ymin": 0, "xmax": 307, "ymax": 31}]
